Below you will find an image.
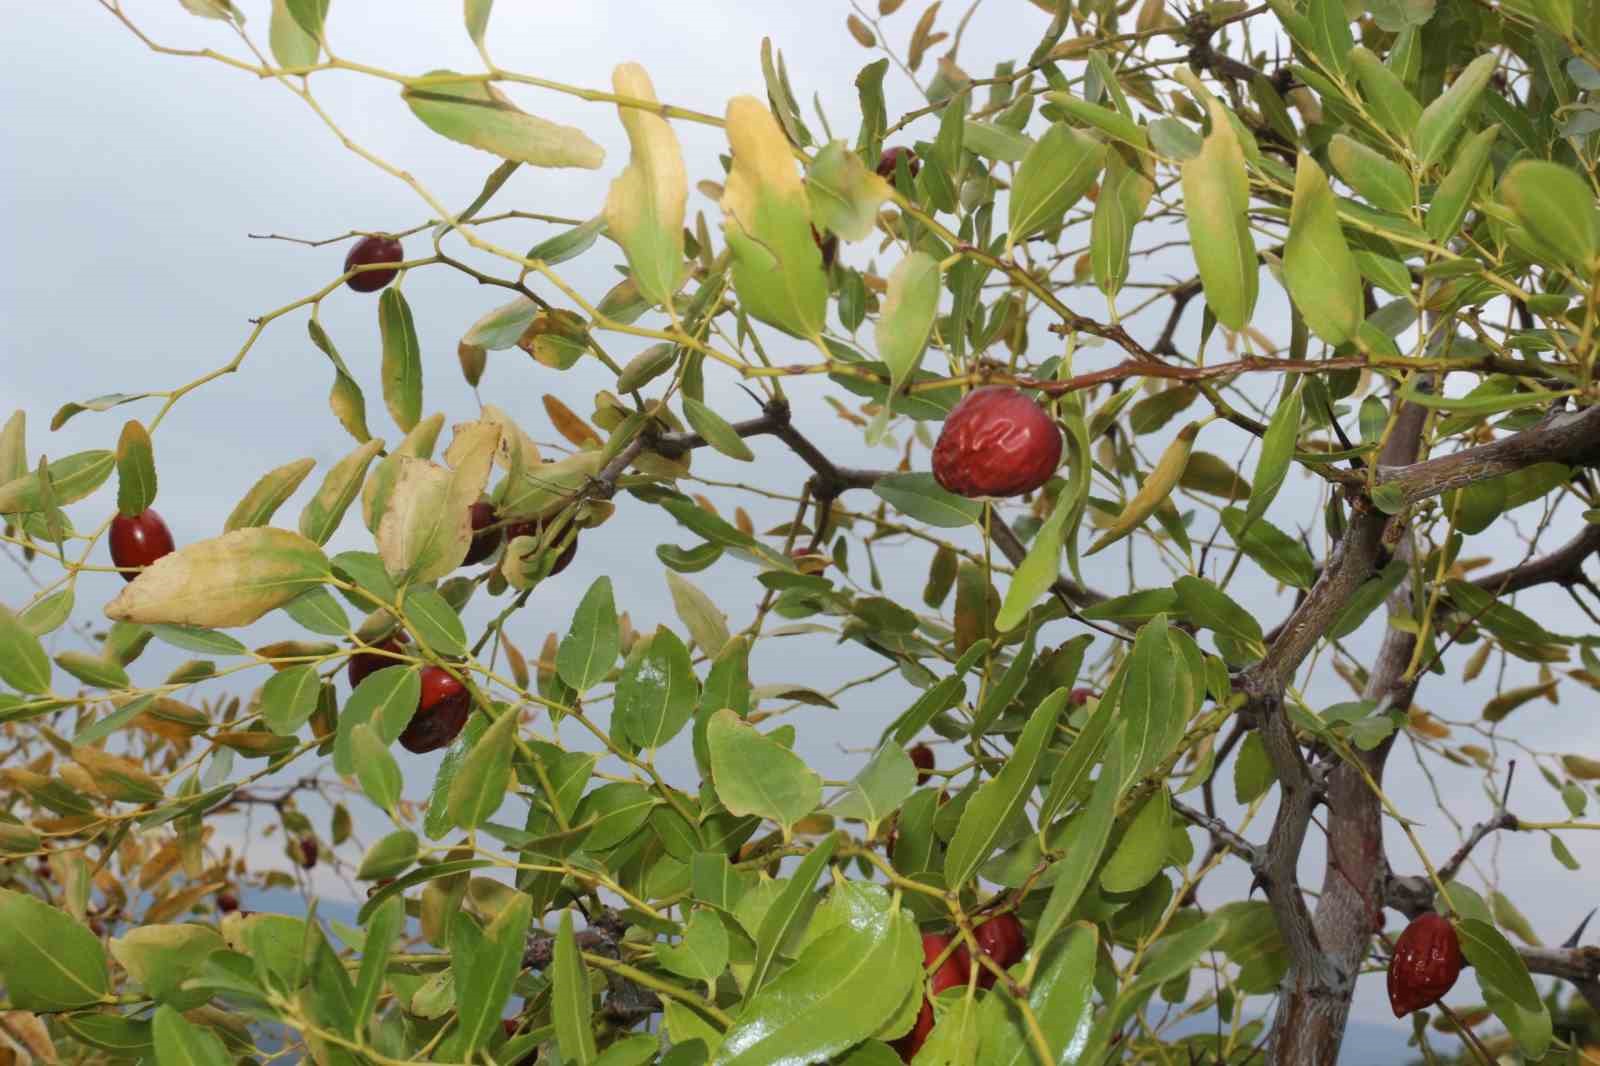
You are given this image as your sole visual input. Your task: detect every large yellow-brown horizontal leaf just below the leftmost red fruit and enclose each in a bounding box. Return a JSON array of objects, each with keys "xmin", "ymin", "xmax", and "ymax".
[{"xmin": 106, "ymin": 527, "xmax": 328, "ymax": 629}]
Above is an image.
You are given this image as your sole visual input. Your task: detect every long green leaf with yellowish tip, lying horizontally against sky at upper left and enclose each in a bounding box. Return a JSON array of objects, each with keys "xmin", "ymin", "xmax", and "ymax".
[{"xmin": 406, "ymin": 70, "xmax": 605, "ymax": 168}]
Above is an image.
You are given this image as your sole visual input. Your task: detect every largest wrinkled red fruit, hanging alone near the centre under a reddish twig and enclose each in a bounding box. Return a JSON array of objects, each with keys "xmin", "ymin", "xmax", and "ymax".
[{"xmin": 933, "ymin": 386, "xmax": 1061, "ymax": 496}]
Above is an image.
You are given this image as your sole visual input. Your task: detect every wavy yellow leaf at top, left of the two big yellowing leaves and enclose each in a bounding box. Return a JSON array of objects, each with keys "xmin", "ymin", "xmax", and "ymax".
[{"xmin": 605, "ymin": 62, "xmax": 690, "ymax": 304}]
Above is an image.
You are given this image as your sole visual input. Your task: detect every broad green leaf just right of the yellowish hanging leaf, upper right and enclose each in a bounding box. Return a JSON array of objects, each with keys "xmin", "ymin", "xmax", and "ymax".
[{"xmin": 1283, "ymin": 152, "xmax": 1365, "ymax": 344}]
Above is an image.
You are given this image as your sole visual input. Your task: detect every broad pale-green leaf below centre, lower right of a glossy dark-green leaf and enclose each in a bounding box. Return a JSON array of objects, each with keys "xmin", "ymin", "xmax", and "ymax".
[{"xmin": 706, "ymin": 709, "xmax": 822, "ymax": 831}]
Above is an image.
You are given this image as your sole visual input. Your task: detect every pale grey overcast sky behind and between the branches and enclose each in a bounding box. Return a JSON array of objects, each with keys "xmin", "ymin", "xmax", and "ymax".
[{"xmin": 0, "ymin": 0, "xmax": 1600, "ymax": 1043}]
